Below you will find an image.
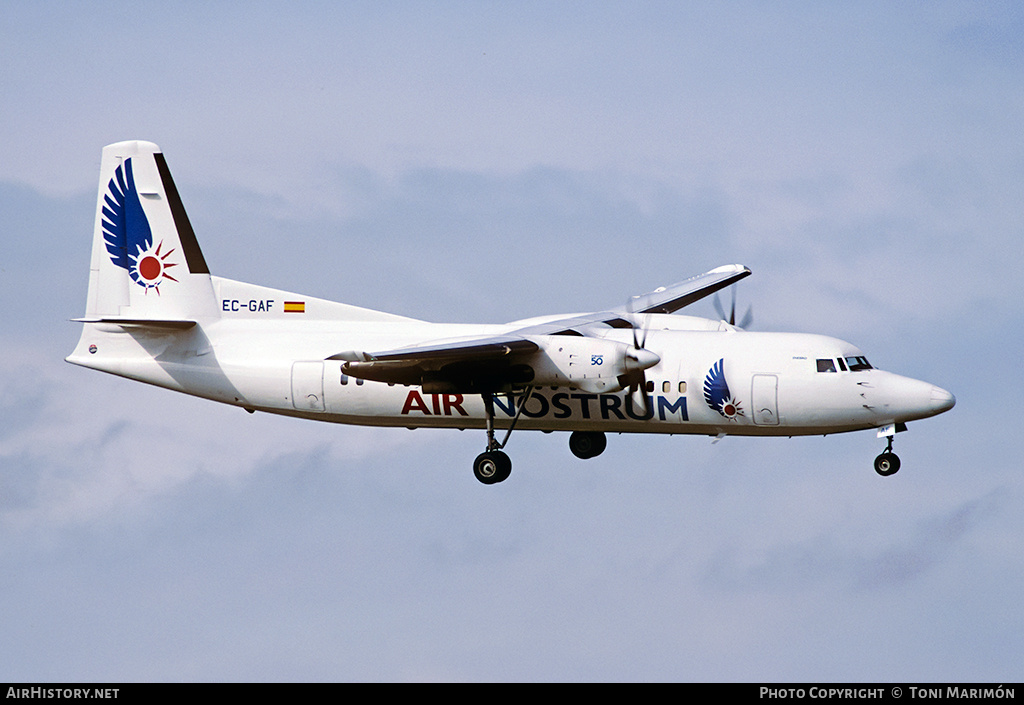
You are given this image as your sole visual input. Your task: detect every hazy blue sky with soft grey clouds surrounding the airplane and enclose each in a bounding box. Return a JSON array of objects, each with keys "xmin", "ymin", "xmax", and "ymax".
[{"xmin": 0, "ymin": 2, "xmax": 1024, "ymax": 682}]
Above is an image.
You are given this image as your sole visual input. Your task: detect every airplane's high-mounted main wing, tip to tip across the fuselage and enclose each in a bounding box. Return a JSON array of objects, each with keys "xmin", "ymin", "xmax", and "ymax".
[{"xmin": 328, "ymin": 264, "xmax": 751, "ymax": 393}]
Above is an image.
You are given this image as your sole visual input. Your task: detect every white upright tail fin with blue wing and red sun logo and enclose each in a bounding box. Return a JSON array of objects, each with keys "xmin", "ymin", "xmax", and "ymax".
[{"xmin": 83, "ymin": 140, "xmax": 217, "ymax": 324}]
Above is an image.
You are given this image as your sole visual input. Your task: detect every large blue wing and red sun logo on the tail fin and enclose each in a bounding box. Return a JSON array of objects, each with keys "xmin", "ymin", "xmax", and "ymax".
[{"xmin": 102, "ymin": 159, "xmax": 178, "ymax": 294}]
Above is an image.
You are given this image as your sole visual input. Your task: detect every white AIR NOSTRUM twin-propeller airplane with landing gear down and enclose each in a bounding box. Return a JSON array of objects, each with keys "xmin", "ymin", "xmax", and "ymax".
[{"xmin": 67, "ymin": 140, "xmax": 955, "ymax": 485}]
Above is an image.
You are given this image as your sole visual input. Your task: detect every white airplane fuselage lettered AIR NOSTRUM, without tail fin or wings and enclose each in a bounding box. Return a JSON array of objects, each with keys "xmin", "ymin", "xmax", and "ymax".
[{"xmin": 69, "ymin": 278, "xmax": 952, "ymax": 436}]
